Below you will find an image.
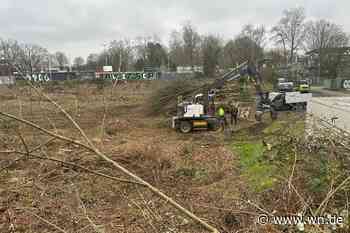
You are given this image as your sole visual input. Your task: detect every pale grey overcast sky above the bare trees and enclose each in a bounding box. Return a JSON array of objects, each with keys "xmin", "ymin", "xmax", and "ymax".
[{"xmin": 0, "ymin": 0, "xmax": 350, "ymax": 60}]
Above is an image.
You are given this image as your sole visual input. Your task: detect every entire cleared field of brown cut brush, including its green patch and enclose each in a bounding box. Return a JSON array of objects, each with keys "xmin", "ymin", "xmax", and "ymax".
[{"xmin": 0, "ymin": 82, "xmax": 349, "ymax": 233}]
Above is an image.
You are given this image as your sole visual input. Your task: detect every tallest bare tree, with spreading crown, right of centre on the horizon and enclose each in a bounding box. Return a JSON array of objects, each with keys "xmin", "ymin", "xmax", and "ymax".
[{"xmin": 271, "ymin": 7, "xmax": 305, "ymax": 63}]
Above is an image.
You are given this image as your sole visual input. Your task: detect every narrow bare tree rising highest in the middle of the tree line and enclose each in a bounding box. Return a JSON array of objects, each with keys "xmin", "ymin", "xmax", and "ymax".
[{"xmin": 182, "ymin": 22, "xmax": 200, "ymax": 67}]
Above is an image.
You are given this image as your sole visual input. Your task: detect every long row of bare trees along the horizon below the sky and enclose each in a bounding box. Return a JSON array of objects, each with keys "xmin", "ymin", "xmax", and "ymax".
[{"xmin": 0, "ymin": 7, "xmax": 349, "ymax": 76}]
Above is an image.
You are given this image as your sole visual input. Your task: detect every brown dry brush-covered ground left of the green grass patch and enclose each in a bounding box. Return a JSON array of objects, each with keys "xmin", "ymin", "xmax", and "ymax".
[{"xmin": 0, "ymin": 83, "xmax": 249, "ymax": 232}]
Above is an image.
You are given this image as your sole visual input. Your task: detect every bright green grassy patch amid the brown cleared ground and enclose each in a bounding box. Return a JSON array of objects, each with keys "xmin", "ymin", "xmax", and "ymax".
[{"xmin": 231, "ymin": 117, "xmax": 305, "ymax": 192}]
